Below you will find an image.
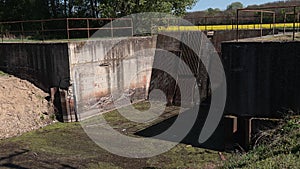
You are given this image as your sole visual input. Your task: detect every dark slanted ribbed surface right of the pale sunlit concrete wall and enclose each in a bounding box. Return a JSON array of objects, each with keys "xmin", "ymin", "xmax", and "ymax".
[{"xmin": 149, "ymin": 32, "xmax": 210, "ymax": 105}]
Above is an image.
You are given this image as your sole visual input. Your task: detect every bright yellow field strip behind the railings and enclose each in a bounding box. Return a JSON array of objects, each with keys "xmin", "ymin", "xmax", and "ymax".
[{"xmin": 158, "ymin": 23, "xmax": 300, "ymax": 31}]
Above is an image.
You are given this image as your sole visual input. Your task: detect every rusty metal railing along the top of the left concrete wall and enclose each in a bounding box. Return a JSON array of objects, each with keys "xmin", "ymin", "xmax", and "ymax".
[{"xmin": 0, "ymin": 18, "xmax": 133, "ymax": 42}]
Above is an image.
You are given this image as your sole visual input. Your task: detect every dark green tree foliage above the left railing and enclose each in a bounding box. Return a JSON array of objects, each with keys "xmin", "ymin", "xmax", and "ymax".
[{"xmin": 0, "ymin": 0, "xmax": 197, "ymax": 21}]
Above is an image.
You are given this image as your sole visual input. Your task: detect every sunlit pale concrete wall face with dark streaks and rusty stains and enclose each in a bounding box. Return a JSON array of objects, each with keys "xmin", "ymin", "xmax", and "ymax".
[{"xmin": 69, "ymin": 37, "xmax": 156, "ymax": 120}]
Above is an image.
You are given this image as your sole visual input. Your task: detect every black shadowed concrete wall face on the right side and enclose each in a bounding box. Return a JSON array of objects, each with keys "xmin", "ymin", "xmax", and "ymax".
[{"xmin": 222, "ymin": 42, "xmax": 300, "ymax": 117}]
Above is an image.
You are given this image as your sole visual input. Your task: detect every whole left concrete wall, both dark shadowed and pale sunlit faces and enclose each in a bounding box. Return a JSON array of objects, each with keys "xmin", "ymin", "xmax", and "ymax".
[{"xmin": 0, "ymin": 36, "xmax": 156, "ymax": 121}]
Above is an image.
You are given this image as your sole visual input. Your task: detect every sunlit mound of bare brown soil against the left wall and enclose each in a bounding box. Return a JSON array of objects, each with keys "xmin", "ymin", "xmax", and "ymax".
[{"xmin": 0, "ymin": 72, "xmax": 52, "ymax": 139}]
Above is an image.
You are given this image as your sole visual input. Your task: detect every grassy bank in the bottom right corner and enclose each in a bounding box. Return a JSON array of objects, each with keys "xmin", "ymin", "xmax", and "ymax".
[{"xmin": 223, "ymin": 116, "xmax": 300, "ymax": 169}]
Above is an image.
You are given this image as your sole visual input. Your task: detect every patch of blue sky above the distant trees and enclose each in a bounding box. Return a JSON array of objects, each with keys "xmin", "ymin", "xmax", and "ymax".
[{"xmin": 188, "ymin": 0, "xmax": 279, "ymax": 12}]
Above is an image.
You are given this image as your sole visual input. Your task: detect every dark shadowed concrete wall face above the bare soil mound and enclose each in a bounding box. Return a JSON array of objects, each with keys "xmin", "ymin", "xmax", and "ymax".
[{"xmin": 0, "ymin": 43, "xmax": 70, "ymax": 92}]
